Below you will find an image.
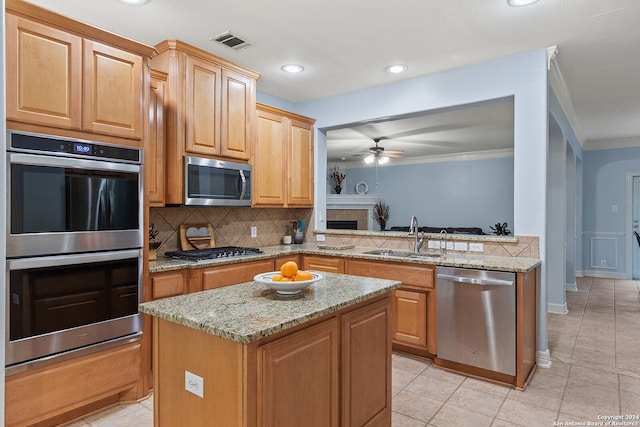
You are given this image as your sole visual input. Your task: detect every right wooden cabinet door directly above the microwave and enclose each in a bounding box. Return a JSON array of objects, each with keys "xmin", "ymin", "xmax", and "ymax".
[{"xmin": 220, "ymin": 70, "xmax": 256, "ymax": 160}]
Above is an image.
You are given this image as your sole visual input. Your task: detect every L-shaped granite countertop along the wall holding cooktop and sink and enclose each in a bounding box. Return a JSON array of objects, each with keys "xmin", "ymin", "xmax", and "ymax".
[{"xmin": 149, "ymin": 243, "xmax": 540, "ymax": 273}]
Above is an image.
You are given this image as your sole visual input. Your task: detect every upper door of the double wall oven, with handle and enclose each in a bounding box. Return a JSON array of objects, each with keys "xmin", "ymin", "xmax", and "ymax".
[{"xmin": 7, "ymin": 153, "xmax": 143, "ymax": 257}]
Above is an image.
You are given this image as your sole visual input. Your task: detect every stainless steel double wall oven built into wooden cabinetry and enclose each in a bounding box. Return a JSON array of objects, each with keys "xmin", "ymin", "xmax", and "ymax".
[{"xmin": 6, "ymin": 131, "xmax": 144, "ymax": 370}]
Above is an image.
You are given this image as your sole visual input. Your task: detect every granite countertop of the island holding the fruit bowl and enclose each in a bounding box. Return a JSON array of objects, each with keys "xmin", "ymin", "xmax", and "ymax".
[{"xmin": 139, "ymin": 272, "xmax": 401, "ymax": 344}]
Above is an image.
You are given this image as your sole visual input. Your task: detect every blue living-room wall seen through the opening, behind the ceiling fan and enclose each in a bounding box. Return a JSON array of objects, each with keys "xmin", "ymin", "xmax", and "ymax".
[{"xmin": 327, "ymin": 157, "xmax": 513, "ymax": 234}]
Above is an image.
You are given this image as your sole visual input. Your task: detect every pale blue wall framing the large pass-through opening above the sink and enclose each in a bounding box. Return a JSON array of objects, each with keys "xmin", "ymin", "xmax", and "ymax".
[{"xmin": 288, "ymin": 49, "xmax": 548, "ymax": 362}]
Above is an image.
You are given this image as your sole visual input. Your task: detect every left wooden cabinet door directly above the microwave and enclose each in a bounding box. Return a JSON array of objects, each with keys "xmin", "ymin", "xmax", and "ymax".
[{"xmin": 185, "ymin": 56, "xmax": 222, "ymax": 156}]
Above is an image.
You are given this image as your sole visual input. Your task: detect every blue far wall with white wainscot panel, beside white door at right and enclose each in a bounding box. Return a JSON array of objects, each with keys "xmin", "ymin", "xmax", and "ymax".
[{"xmin": 582, "ymin": 147, "xmax": 640, "ymax": 278}]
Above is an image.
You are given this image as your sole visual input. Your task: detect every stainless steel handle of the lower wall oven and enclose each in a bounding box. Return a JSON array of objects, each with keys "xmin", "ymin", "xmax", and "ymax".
[{"xmin": 7, "ymin": 249, "xmax": 142, "ymax": 271}]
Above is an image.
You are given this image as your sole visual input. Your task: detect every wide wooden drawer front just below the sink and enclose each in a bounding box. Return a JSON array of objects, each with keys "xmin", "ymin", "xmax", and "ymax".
[{"xmin": 346, "ymin": 260, "xmax": 435, "ymax": 289}]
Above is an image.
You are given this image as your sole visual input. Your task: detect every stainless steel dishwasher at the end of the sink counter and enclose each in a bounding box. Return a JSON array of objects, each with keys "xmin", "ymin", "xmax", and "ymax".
[{"xmin": 436, "ymin": 267, "xmax": 516, "ymax": 375}]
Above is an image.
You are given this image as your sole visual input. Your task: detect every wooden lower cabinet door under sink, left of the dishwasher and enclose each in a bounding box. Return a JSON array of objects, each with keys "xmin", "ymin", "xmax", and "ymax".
[{"xmin": 393, "ymin": 289, "xmax": 427, "ymax": 350}]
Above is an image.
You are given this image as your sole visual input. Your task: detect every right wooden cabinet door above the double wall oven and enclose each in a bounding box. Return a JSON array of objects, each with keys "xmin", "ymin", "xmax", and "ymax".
[{"xmin": 83, "ymin": 39, "xmax": 144, "ymax": 139}]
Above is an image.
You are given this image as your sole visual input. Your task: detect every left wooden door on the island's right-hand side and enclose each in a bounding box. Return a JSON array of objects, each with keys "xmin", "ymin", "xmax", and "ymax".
[{"xmin": 258, "ymin": 318, "xmax": 340, "ymax": 427}]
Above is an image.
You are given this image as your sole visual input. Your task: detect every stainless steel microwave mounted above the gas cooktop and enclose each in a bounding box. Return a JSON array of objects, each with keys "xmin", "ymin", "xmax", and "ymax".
[{"xmin": 184, "ymin": 156, "xmax": 251, "ymax": 206}]
